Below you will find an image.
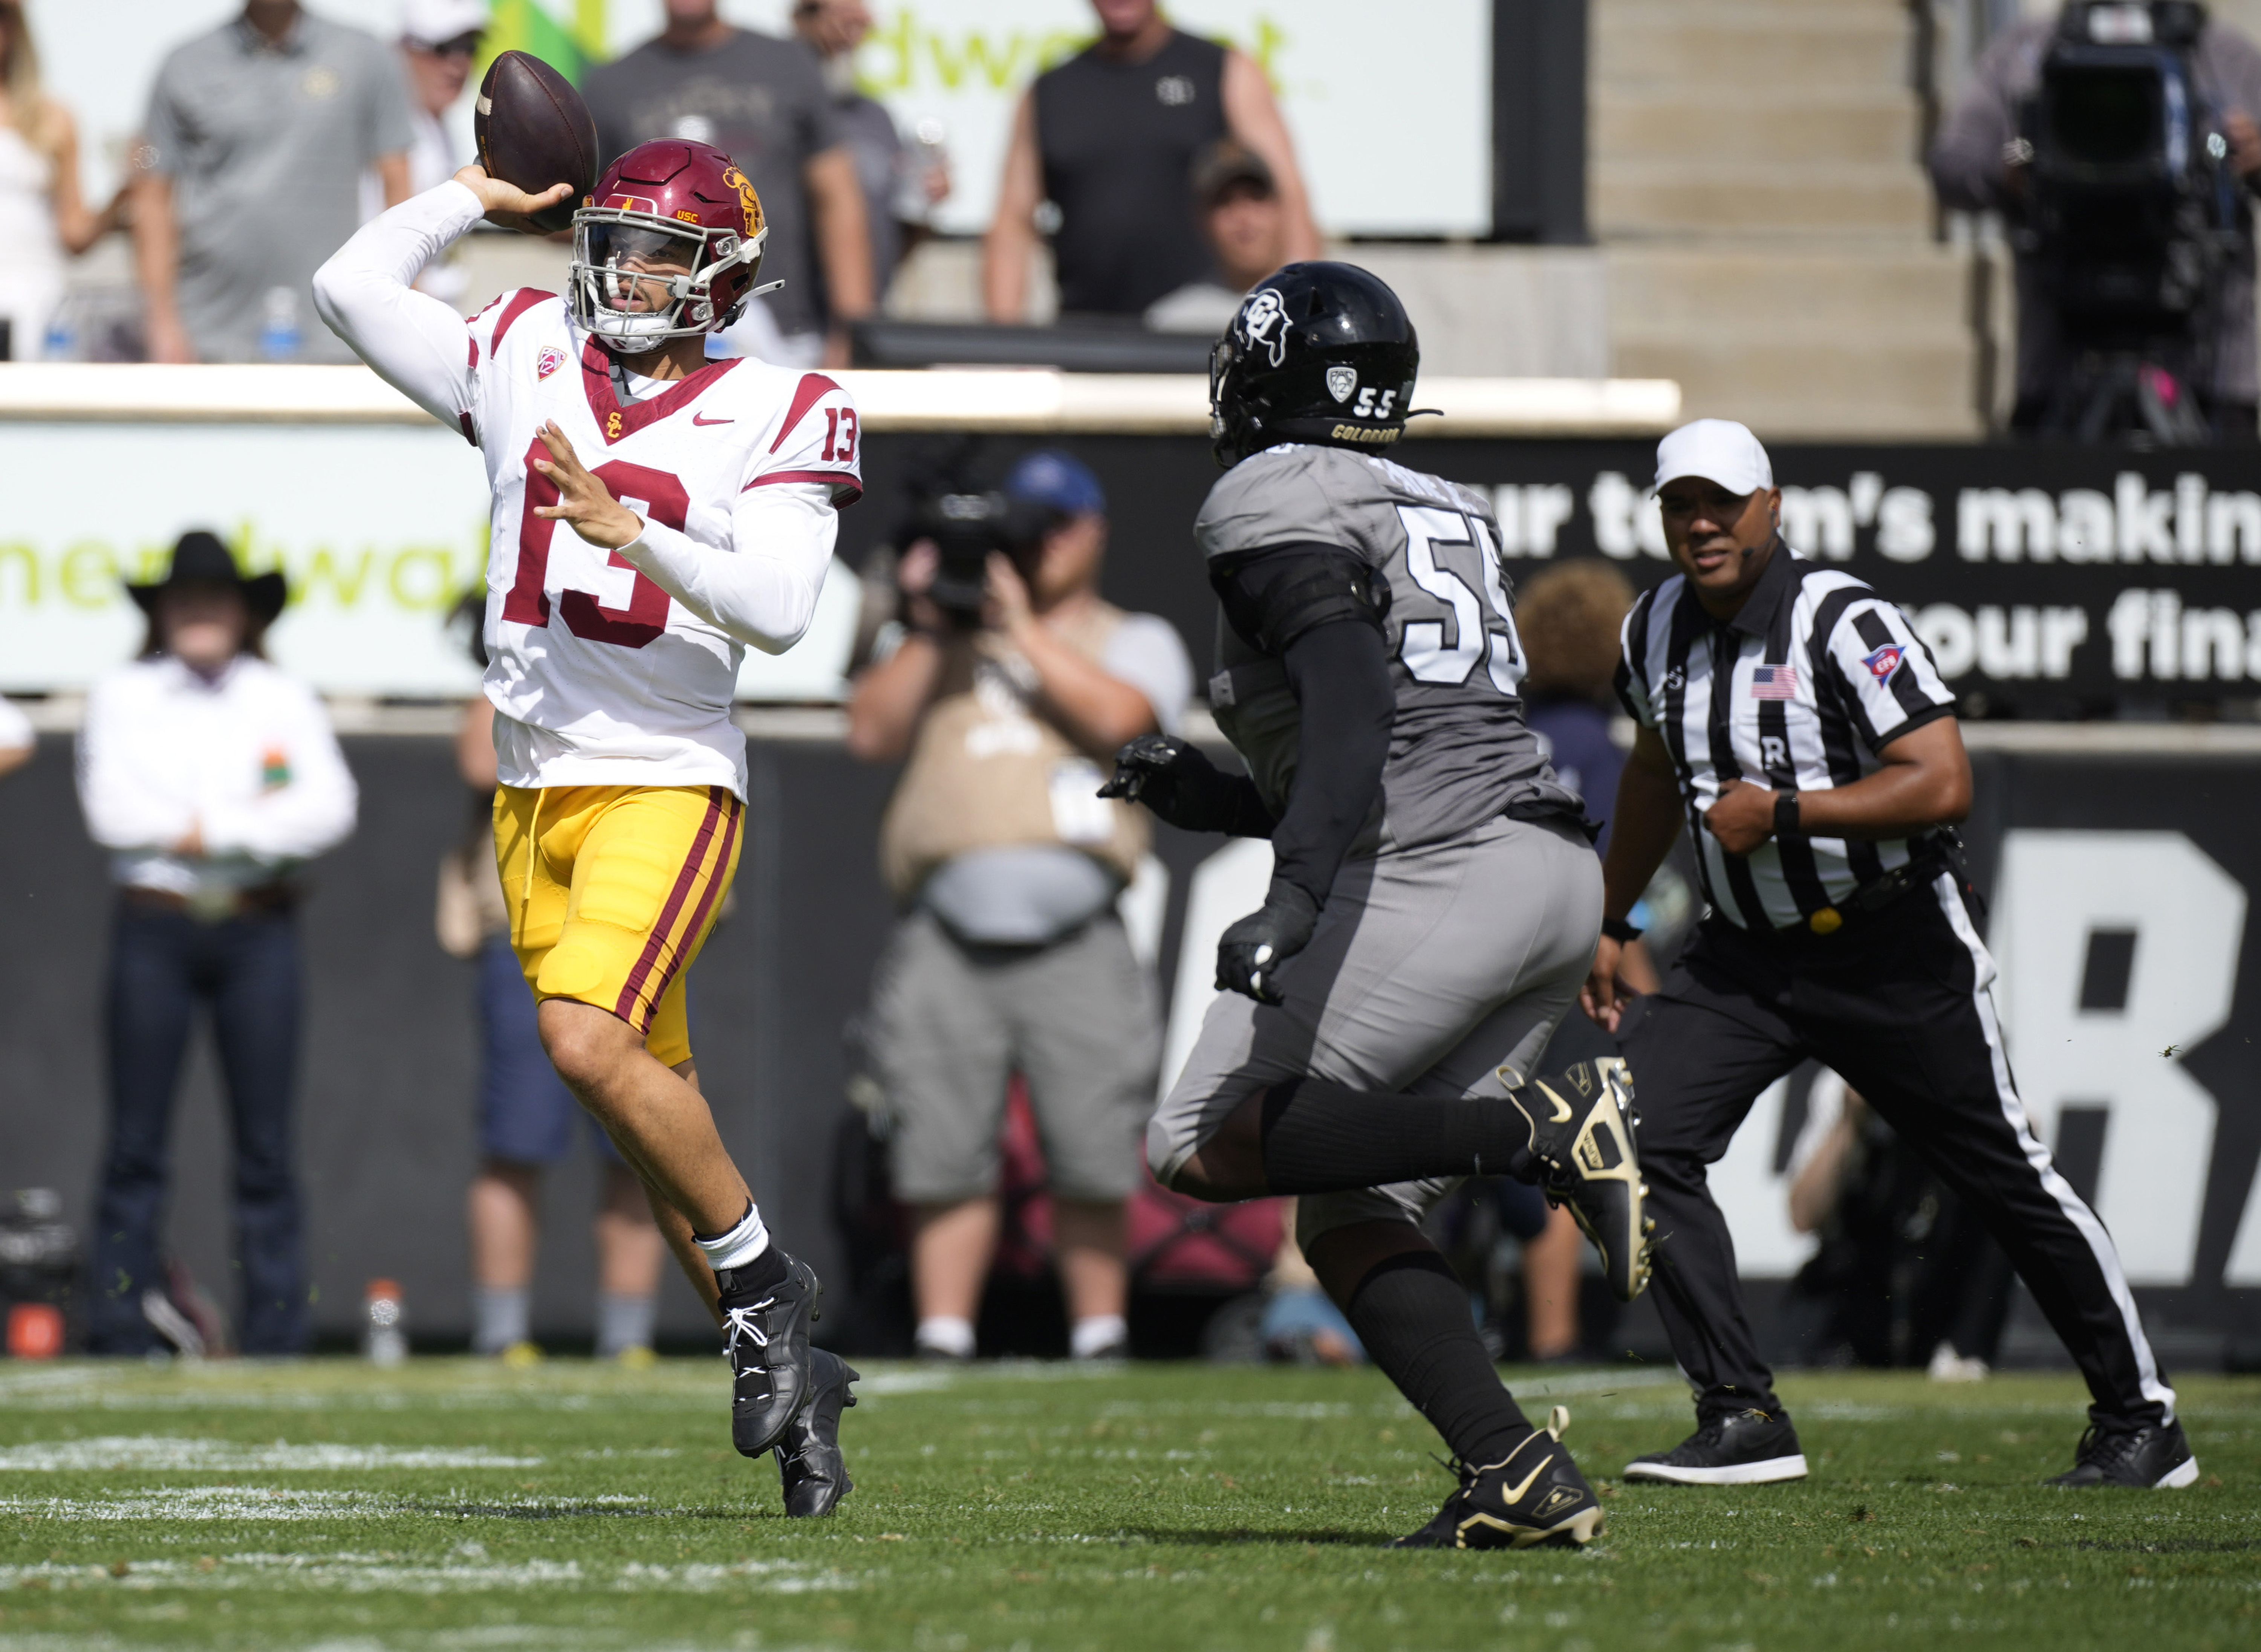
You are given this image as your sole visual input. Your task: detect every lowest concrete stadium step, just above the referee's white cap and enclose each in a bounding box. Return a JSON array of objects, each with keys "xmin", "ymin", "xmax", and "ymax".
[{"xmin": 1612, "ymin": 328, "xmax": 1983, "ymax": 441}]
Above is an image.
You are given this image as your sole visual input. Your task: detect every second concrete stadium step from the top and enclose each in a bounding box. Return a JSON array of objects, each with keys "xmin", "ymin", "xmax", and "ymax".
[{"xmin": 1589, "ymin": 86, "xmax": 1920, "ymax": 165}]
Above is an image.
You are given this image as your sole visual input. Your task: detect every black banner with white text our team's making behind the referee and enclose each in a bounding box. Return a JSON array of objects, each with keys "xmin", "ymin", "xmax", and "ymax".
[{"xmin": 868, "ymin": 436, "xmax": 2261, "ymax": 719}]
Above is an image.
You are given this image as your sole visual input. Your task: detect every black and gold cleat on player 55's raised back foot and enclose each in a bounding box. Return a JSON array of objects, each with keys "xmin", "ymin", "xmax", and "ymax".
[{"xmin": 1501, "ymin": 1055, "xmax": 1657, "ymax": 1302}]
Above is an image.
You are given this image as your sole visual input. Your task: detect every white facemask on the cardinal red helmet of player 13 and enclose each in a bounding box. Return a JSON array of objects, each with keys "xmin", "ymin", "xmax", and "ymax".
[{"xmin": 568, "ymin": 208, "xmax": 769, "ymax": 355}]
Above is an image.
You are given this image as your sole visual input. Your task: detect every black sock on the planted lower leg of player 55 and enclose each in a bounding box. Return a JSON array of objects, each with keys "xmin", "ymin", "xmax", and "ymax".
[{"xmin": 1348, "ymin": 1250, "xmax": 1531, "ymax": 1467}]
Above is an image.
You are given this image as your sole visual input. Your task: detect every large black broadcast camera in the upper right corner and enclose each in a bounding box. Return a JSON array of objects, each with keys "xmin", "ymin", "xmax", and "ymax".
[{"xmin": 2006, "ymin": 0, "xmax": 2250, "ymax": 443}]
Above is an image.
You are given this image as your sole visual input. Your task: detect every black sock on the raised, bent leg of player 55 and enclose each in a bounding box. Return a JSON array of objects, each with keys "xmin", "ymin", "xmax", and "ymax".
[{"xmin": 1264, "ymin": 1078, "xmax": 1531, "ymax": 1193}]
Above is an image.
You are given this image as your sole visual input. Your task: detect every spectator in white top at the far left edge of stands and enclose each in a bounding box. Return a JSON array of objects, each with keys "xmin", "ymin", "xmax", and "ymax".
[{"xmin": 0, "ymin": 0, "xmax": 124, "ymax": 362}]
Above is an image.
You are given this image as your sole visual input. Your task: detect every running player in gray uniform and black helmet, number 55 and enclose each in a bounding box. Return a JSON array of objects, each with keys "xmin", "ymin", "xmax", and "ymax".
[{"xmin": 1108, "ymin": 262, "xmax": 1648, "ymax": 1548}]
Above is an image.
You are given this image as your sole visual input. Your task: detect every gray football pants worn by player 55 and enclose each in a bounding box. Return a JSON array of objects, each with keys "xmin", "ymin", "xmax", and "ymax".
[{"xmin": 1146, "ymin": 818, "xmax": 1601, "ymax": 1245}]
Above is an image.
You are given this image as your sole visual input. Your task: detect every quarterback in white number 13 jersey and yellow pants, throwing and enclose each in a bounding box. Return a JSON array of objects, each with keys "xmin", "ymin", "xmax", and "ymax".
[{"xmin": 314, "ymin": 140, "xmax": 861, "ymax": 1514}]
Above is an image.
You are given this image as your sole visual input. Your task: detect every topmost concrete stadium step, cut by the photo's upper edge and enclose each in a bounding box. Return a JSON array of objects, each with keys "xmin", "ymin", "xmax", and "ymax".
[{"xmin": 1592, "ymin": 0, "xmax": 1908, "ymax": 90}]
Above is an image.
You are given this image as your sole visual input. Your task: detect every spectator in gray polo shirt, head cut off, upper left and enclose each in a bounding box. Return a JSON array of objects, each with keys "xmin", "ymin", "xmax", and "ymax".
[{"xmin": 133, "ymin": 0, "xmax": 416, "ymax": 362}]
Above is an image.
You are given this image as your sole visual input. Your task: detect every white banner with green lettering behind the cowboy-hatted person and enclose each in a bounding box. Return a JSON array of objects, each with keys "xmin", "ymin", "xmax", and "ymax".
[{"xmin": 0, "ymin": 425, "xmax": 857, "ymax": 701}]
